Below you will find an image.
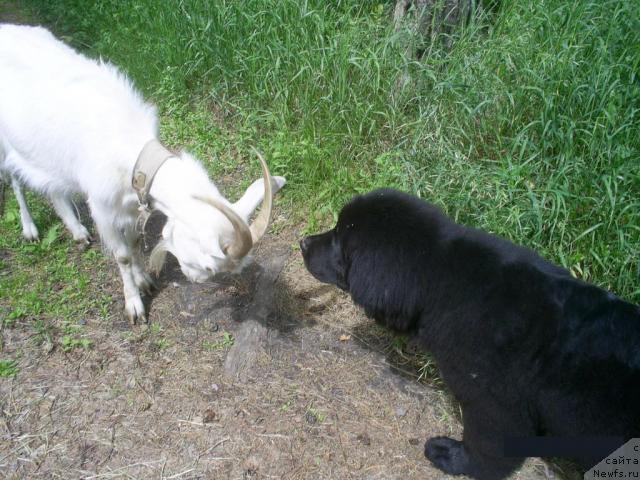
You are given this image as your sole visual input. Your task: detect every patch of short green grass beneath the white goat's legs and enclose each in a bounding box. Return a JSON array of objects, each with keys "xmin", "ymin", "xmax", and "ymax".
[{"xmin": 0, "ymin": 195, "xmax": 112, "ymax": 352}]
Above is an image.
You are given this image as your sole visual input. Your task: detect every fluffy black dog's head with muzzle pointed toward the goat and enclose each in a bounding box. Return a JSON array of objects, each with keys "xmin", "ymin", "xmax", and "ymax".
[{"xmin": 300, "ymin": 189, "xmax": 441, "ymax": 330}]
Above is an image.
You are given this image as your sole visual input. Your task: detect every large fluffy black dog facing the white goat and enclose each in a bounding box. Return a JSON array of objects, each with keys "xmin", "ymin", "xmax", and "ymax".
[{"xmin": 300, "ymin": 190, "xmax": 640, "ymax": 479}]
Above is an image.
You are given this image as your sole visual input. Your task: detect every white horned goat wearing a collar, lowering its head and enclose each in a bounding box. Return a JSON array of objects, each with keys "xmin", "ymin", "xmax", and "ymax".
[{"xmin": 0, "ymin": 25, "xmax": 285, "ymax": 323}]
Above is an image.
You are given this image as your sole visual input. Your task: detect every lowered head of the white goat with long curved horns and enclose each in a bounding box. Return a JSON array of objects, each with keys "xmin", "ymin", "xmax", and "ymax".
[{"xmin": 150, "ymin": 152, "xmax": 284, "ymax": 282}]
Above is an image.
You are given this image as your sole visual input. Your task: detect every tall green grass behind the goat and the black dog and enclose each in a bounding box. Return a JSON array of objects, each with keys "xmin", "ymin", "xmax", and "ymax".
[{"xmin": 17, "ymin": 0, "xmax": 640, "ymax": 302}]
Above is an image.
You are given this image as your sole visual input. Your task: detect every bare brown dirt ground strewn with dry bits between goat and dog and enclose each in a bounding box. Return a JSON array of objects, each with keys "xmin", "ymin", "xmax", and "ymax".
[{"xmin": 0, "ymin": 205, "xmax": 555, "ymax": 480}]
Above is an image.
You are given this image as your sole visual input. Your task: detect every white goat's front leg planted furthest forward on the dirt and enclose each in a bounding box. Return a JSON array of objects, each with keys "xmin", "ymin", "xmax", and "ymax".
[{"xmin": 89, "ymin": 201, "xmax": 147, "ymax": 325}]
